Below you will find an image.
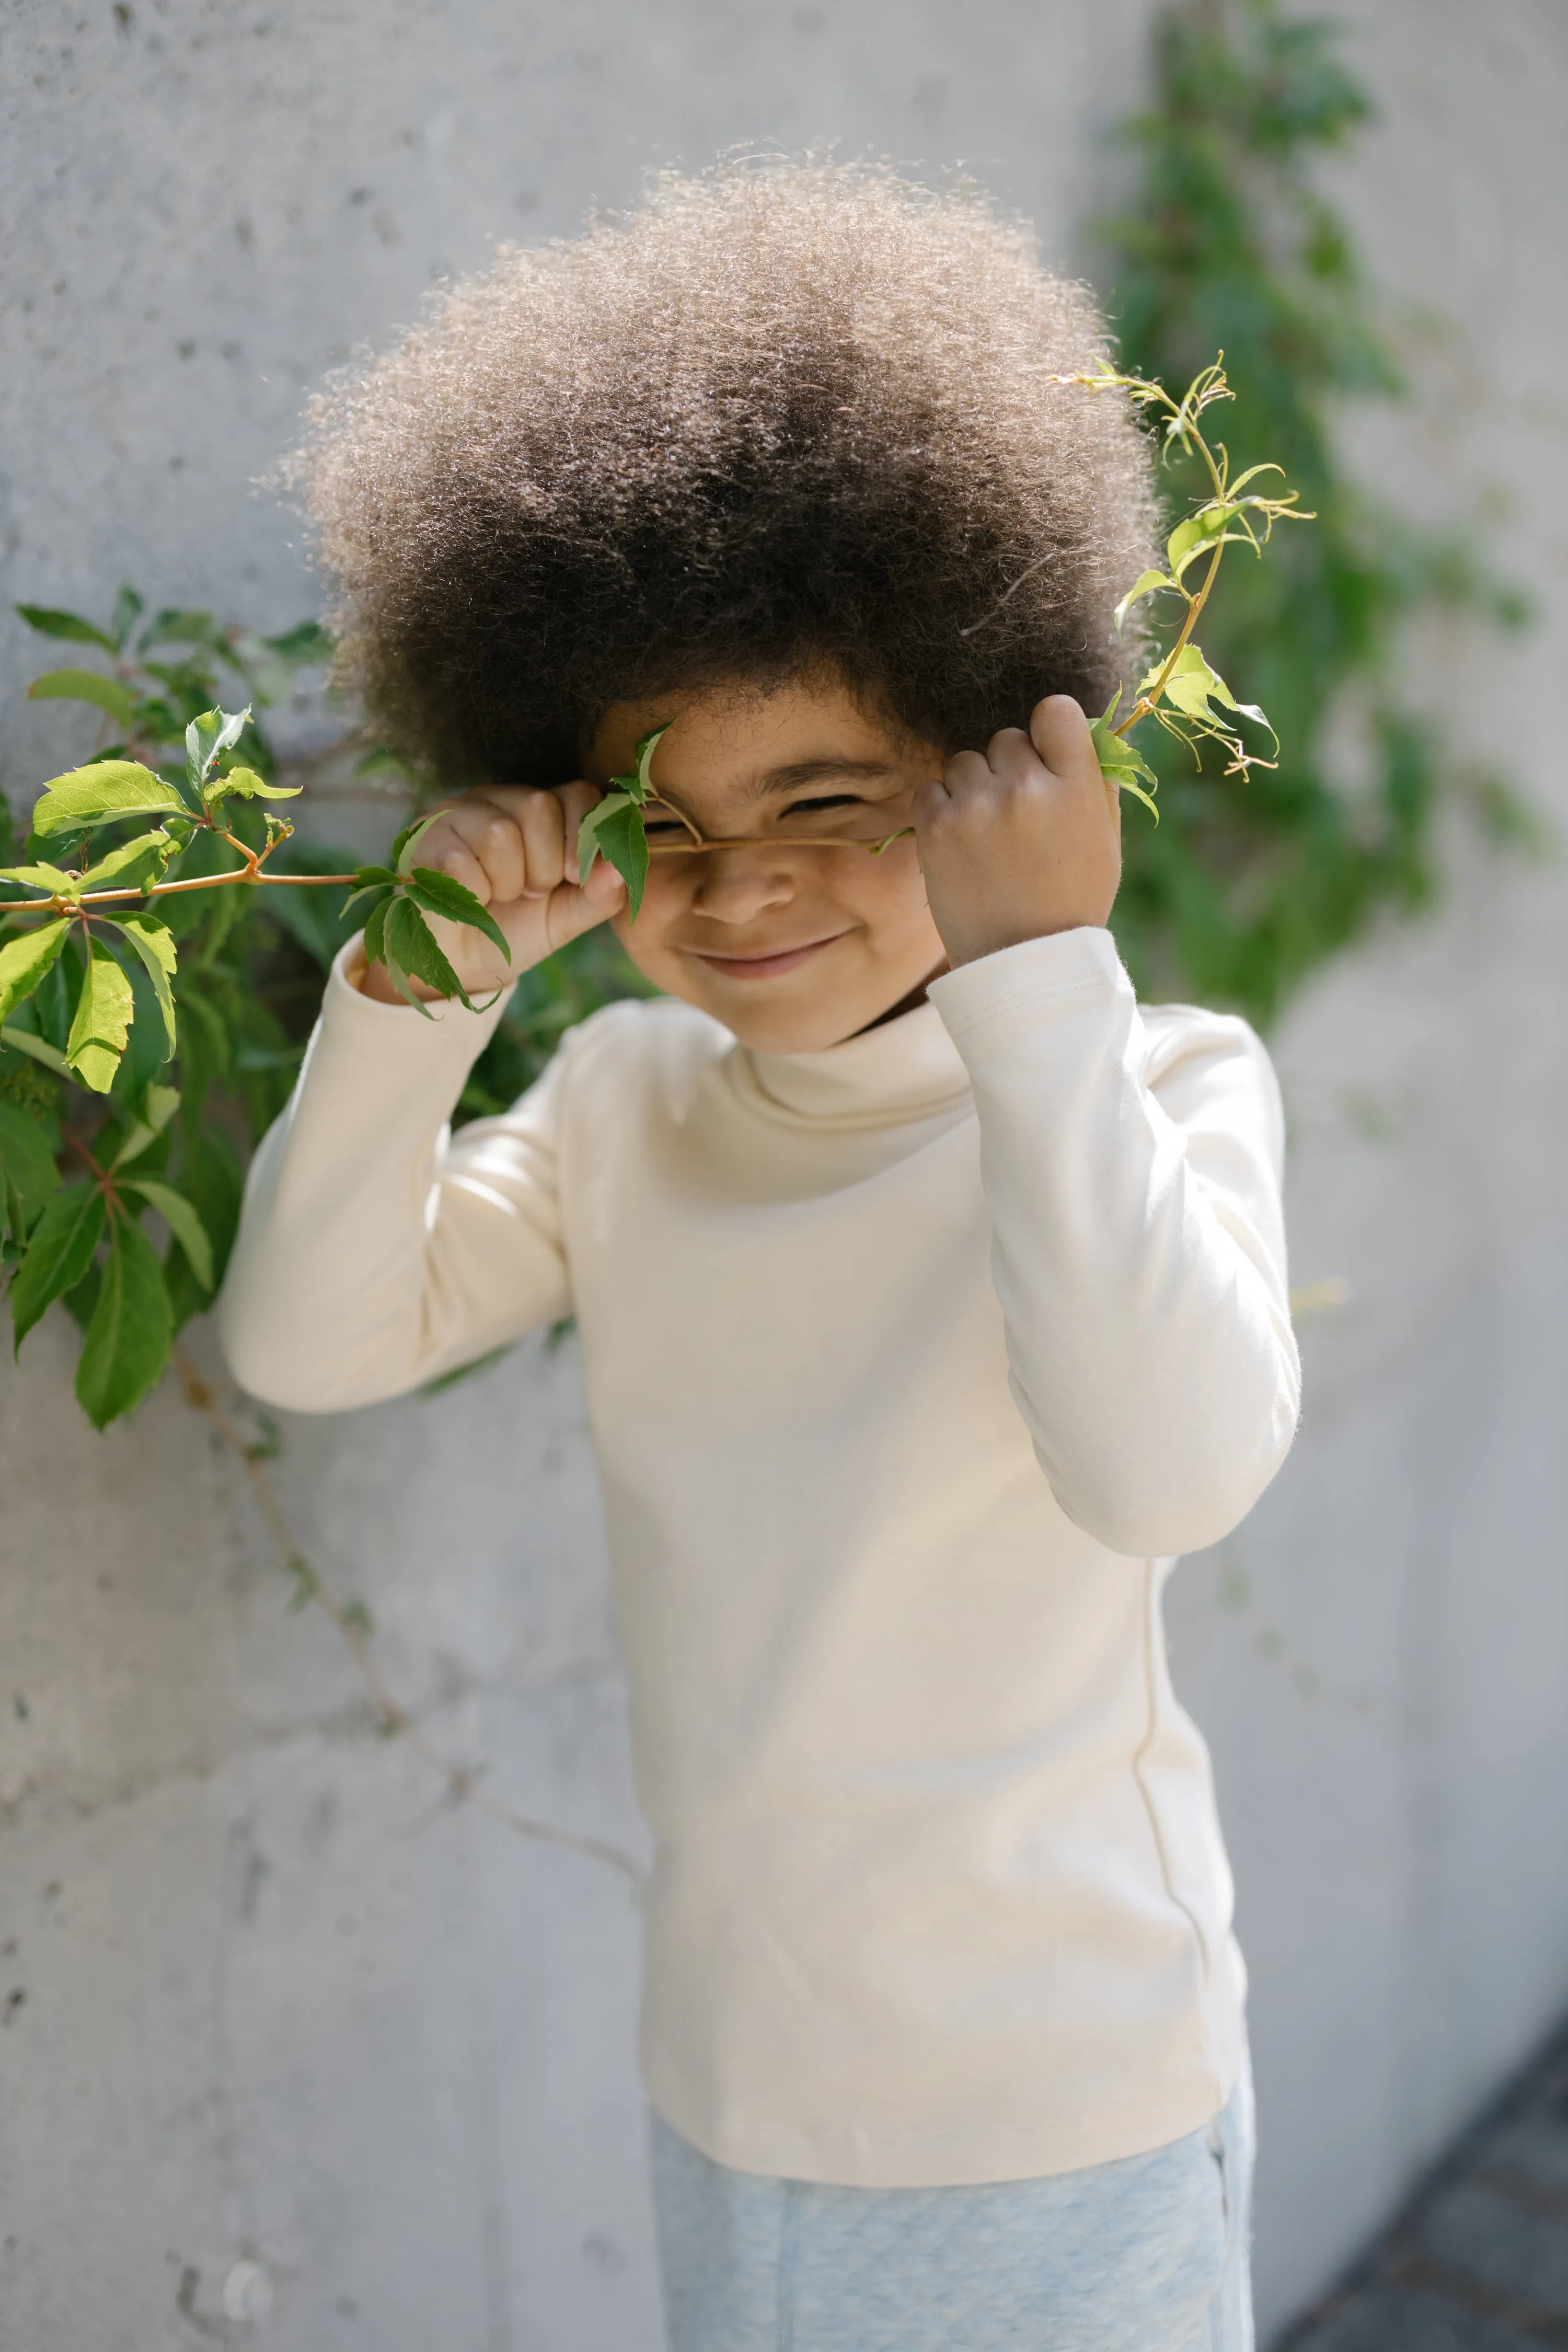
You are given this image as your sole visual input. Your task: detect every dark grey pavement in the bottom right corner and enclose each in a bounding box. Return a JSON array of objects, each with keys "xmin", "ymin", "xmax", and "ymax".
[{"xmin": 1276, "ymin": 2035, "xmax": 1568, "ymax": 2352}]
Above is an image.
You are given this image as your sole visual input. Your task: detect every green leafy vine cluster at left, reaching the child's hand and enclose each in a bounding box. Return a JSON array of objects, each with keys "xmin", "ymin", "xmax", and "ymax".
[{"xmin": 0, "ymin": 588, "xmax": 647, "ymax": 1428}]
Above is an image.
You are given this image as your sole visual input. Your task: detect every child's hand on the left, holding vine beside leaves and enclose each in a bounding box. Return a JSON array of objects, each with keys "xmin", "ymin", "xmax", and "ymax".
[{"xmin": 362, "ymin": 783, "xmax": 625, "ymax": 1005}]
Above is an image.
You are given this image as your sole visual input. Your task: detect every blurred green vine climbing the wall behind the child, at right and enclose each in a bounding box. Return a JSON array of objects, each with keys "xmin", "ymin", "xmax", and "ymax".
[{"xmin": 1102, "ymin": 0, "xmax": 1538, "ymax": 1023}]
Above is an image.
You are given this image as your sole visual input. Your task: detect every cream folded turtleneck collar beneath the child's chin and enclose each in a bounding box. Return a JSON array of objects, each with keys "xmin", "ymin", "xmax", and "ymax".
[{"xmin": 729, "ymin": 1005, "xmax": 969, "ymax": 1127}]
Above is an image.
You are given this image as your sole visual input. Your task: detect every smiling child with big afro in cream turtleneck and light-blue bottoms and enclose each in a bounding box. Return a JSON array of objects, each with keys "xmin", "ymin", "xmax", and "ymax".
[{"xmin": 223, "ymin": 165, "xmax": 1298, "ymax": 2352}]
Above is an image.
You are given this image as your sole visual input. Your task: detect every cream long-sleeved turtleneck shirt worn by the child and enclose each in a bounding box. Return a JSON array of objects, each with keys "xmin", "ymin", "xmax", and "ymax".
[{"xmin": 221, "ymin": 929, "xmax": 1298, "ymax": 2185}]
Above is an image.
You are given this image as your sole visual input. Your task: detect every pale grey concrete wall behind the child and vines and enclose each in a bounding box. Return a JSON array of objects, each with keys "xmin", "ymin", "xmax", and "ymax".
[{"xmin": 0, "ymin": 0, "xmax": 1568, "ymax": 2352}]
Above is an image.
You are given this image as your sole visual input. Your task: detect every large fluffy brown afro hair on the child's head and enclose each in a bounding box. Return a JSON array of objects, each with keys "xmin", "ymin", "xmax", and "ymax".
[{"xmin": 294, "ymin": 160, "xmax": 1154, "ymax": 786}]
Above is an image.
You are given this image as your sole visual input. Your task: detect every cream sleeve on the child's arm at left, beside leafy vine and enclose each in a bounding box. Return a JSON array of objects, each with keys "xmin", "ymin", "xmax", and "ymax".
[{"xmin": 218, "ymin": 941, "xmax": 569, "ymax": 1411}]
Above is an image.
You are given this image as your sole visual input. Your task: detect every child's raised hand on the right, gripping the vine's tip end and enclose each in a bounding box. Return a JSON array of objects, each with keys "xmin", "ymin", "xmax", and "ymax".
[{"xmin": 915, "ymin": 694, "xmax": 1121, "ymax": 967}]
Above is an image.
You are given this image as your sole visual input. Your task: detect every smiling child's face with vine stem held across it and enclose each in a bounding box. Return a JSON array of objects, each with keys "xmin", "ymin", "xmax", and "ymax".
[{"xmin": 585, "ymin": 680, "xmax": 945, "ymax": 1054}]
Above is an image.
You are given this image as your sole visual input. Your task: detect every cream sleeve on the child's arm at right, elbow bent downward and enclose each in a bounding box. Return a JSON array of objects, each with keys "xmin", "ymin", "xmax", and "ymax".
[{"xmin": 931, "ymin": 929, "xmax": 1300, "ymax": 1557}]
